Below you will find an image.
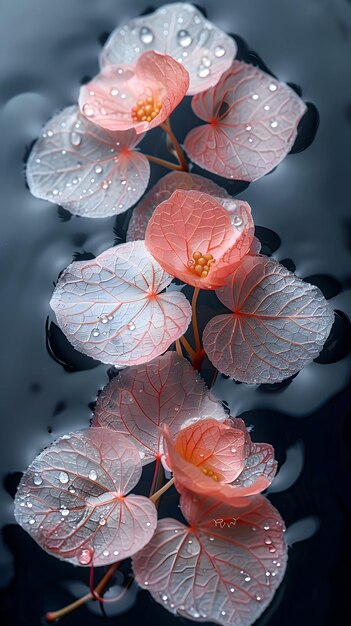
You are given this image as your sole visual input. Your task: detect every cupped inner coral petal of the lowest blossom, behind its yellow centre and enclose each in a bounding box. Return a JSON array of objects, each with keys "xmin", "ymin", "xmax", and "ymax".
[{"xmin": 175, "ymin": 419, "xmax": 245, "ymax": 483}]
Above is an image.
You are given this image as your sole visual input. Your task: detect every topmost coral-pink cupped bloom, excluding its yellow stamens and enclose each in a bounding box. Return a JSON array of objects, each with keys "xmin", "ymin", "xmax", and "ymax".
[{"xmin": 79, "ymin": 51, "xmax": 189, "ymax": 134}]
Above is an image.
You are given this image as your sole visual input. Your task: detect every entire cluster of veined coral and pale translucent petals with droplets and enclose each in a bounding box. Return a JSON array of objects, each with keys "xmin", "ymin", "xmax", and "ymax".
[{"xmin": 15, "ymin": 3, "xmax": 333, "ymax": 626}]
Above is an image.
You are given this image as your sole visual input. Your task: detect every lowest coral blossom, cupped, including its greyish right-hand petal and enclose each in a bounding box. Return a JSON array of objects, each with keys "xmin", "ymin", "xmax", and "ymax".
[{"xmin": 163, "ymin": 419, "xmax": 276, "ymax": 504}]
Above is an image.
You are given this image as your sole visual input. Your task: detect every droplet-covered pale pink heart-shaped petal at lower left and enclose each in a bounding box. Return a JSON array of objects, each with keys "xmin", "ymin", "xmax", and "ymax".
[{"xmin": 15, "ymin": 428, "xmax": 157, "ymax": 566}]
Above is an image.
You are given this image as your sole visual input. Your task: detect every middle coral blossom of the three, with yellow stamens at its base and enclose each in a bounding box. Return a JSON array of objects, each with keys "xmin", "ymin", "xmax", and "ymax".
[{"xmin": 145, "ymin": 191, "xmax": 254, "ymax": 289}]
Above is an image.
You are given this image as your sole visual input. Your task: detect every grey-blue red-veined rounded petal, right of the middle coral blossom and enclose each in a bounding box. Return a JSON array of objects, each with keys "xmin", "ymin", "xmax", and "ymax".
[{"xmin": 203, "ymin": 256, "xmax": 334, "ymax": 383}]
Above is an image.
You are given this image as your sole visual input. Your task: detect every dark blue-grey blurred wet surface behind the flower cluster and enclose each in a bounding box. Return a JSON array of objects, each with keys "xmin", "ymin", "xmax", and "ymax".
[{"xmin": 0, "ymin": 0, "xmax": 351, "ymax": 626}]
